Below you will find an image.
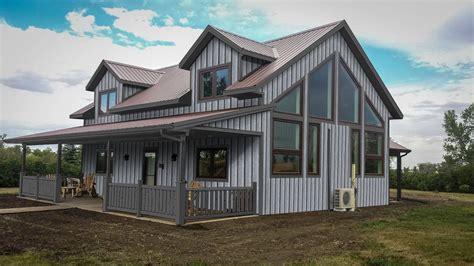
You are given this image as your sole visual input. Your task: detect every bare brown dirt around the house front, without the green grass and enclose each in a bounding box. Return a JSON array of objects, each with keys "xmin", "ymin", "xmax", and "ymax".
[{"xmin": 0, "ymin": 192, "xmax": 436, "ymax": 264}]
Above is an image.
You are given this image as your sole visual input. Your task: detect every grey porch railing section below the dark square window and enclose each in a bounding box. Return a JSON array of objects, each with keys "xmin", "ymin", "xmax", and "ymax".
[{"xmin": 186, "ymin": 182, "xmax": 257, "ymax": 220}]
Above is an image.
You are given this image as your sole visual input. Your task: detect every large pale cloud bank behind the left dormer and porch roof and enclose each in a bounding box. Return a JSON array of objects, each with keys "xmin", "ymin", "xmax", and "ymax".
[{"xmin": 0, "ymin": 20, "xmax": 202, "ymax": 137}]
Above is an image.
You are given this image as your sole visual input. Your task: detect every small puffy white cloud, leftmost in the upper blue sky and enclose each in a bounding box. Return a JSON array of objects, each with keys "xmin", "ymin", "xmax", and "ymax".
[{"xmin": 66, "ymin": 9, "xmax": 110, "ymax": 36}]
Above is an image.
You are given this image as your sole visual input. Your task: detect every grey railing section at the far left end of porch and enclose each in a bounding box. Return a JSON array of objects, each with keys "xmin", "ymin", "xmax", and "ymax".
[{"xmin": 20, "ymin": 176, "xmax": 56, "ymax": 201}]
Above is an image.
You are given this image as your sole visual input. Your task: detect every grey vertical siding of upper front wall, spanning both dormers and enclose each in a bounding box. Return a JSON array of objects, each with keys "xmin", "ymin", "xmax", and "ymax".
[{"xmin": 84, "ymin": 35, "xmax": 261, "ymax": 125}]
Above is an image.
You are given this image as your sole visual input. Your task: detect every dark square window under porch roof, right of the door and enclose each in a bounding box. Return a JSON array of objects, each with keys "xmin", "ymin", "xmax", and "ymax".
[{"xmin": 196, "ymin": 148, "xmax": 227, "ymax": 179}]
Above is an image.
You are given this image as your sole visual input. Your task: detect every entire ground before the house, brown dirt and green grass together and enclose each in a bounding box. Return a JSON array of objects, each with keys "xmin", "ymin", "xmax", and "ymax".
[{"xmin": 0, "ymin": 191, "xmax": 474, "ymax": 265}]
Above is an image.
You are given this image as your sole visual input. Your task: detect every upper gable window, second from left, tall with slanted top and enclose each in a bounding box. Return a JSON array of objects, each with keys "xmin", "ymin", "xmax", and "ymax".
[{"xmin": 308, "ymin": 60, "xmax": 333, "ymax": 119}]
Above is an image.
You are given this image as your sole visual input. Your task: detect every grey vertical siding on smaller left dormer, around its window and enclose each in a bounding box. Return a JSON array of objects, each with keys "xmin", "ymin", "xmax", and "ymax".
[{"xmin": 94, "ymin": 71, "xmax": 122, "ymax": 125}]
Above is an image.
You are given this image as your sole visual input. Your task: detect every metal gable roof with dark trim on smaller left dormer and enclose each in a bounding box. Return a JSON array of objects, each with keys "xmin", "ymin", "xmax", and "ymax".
[{"xmin": 86, "ymin": 60, "xmax": 163, "ymax": 91}]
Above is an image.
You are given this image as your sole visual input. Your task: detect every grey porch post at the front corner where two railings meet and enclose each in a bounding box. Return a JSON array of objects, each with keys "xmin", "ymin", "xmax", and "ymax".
[{"xmin": 175, "ymin": 136, "xmax": 186, "ymax": 225}]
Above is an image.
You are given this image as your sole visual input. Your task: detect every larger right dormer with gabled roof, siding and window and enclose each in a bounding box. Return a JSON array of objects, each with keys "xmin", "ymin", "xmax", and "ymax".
[{"xmin": 179, "ymin": 26, "xmax": 278, "ymax": 102}]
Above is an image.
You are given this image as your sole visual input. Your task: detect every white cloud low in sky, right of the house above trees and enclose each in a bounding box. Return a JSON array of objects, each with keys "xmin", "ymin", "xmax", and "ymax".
[{"xmin": 390, "ymin": 78, "xmax": 474, "ymax": 166}]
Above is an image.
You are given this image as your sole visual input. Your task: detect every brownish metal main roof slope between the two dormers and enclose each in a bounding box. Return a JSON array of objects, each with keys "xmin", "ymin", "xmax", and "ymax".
[{"xmin": 111, "ymin": 65, "xmax": 190, "ymax": 113}]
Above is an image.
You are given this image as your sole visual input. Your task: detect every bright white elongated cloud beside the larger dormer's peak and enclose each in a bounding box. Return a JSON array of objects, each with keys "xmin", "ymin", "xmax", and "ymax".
[{"xmin": 104, "ymin": 8, "xmax": 202, "ymax": 49}]
